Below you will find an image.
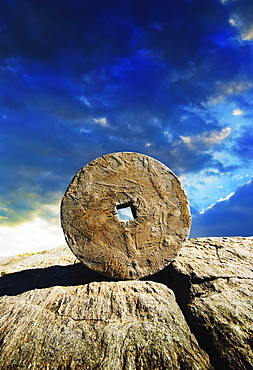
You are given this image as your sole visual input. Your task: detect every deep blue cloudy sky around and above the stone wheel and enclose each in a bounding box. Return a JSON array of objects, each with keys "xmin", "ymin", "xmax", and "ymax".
[{"xmin": 0, "ymin": 0, "xmax": 253, "ymax": 256}]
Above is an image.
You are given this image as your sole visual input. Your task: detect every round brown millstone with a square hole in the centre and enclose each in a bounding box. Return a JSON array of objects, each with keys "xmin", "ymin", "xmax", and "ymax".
[{"xmin": 61, "ymin": 152, "xmax": 191, "ymax": 279}]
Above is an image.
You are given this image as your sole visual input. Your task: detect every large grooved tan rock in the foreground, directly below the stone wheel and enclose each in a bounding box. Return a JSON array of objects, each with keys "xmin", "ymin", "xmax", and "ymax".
[{"xmin": 0, "ymin": 281, "xmax": 211, "ymax": 370}]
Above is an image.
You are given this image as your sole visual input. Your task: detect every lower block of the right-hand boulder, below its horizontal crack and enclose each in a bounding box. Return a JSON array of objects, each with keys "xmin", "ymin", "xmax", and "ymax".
[{"xmin": 188, "ymin": 278, "xmax": 253, "ymax": 370}]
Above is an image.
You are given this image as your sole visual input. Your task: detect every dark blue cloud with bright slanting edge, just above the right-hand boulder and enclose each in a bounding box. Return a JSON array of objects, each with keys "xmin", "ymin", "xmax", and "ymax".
[{"xmin": 191, "ymin": 180, "xmax": 253, "ymax": 237}]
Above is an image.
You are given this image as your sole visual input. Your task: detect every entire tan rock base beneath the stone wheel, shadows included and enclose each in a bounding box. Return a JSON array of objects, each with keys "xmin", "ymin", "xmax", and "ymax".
[{"xmin": 0, "ymin": 237, "xmax": 253, "ymax": 370}]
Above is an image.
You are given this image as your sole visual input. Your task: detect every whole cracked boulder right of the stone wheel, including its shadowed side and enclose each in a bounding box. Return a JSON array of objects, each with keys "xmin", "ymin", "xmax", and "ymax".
[{"xmin": 167, "ymin": 237, "xmax": 253, "ymax": 370}]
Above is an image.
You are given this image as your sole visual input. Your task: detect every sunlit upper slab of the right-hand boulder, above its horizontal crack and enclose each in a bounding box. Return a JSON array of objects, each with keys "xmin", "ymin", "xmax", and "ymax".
[{"xmin": 169, "ymin": 237, "xmax": 253, "ymax": 280}]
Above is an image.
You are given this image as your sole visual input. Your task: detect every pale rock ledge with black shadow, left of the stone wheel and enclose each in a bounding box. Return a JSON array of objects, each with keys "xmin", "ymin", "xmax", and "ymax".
[{"xmin": 0, "ymin": 245, "xmax": 108, "ymax": 296}]
